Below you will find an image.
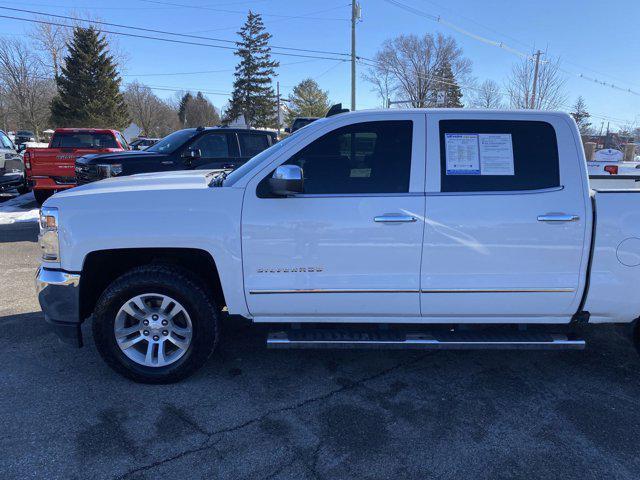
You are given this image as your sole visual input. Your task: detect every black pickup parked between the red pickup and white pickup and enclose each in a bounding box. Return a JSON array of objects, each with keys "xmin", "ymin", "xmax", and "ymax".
[{"xmin": 76, "ymin": 127, "xmax": 276, "ymax": 185}]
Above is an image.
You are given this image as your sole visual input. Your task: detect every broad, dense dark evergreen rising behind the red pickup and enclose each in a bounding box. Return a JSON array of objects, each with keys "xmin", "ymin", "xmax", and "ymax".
[{"xmin": 51, "ymin": 27, "xmax": 129, "ymax": 128}]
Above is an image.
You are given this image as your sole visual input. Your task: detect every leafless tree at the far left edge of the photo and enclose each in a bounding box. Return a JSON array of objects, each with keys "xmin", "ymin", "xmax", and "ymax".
[{"xmin": 0, "ymin": 39, "xmax": 55, "ymax": 135}]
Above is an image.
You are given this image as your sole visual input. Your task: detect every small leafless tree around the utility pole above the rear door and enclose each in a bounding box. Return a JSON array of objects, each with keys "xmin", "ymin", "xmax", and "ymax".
[{"xmin": 507, "ymin": 53, "xmax": 567, "ymax": 110}]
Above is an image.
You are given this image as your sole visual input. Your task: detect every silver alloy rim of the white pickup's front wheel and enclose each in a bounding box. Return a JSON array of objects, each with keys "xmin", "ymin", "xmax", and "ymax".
[{"xmin": 113, "ymin": 293, "xmax": 193, "ymax": 367}]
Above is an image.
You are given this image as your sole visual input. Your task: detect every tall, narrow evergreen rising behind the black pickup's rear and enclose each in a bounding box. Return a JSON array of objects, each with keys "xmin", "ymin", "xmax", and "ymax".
[{"xmin": 225, "ymin": 11, "xmax": 279, "ymax": 127}]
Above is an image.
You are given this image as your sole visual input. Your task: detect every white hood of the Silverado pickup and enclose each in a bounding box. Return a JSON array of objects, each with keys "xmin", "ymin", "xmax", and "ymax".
[{"xmin": 50, "ymin": 170, "xmax": 220, "ymax": 199}]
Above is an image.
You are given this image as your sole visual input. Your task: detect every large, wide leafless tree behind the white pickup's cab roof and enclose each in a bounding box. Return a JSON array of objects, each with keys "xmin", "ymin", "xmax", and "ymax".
[{"xmin": 366, "ymin": 33, "xmax": 471, "ymax": 107}]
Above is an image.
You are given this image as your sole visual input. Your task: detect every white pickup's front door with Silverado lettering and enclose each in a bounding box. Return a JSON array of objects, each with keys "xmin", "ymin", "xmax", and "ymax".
[{"xmin": 242, "ymin": 114, "xmax": 424, "ymax": 321}]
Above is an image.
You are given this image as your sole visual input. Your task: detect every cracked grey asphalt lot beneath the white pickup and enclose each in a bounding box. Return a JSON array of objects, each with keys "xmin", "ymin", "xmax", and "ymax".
[{"xmin": 0, "ymin": 193, "xmax": 640, "ymax": 480}]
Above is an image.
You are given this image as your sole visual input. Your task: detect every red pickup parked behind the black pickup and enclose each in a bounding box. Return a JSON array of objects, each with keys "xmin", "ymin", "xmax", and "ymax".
[{"xmin": 24, "ymin": 128, "xmax": 129, "ymax": 205}]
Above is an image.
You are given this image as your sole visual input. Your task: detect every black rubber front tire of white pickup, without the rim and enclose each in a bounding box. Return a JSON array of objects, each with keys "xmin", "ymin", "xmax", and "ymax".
[{"xmin": 93, "ymin": 265, "xmax": 220, "ymax": 384}]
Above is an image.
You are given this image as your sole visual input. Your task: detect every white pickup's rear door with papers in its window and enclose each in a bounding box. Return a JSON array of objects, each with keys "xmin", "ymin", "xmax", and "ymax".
[{"xmin": 421, "ymin": 114, "xmax": 591, "ymax": 322}]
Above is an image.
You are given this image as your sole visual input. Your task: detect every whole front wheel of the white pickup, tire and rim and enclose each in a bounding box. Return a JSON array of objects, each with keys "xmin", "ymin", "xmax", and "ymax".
[{"xmin": 93, "ymin": 265, "xmax": 219, "ymax": 383}]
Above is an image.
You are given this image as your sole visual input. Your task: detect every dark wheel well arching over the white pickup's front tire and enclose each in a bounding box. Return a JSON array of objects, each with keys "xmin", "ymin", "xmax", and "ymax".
[{"xmin": 80, "ymin": 248, "xmax": 226, "ymax": 319}]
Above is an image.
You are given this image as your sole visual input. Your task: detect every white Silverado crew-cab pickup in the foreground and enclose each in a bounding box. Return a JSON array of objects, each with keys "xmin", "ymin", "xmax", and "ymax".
[{"xmin": 37, "ymin": 109, "xmax": 640, "ymax": 383}]
